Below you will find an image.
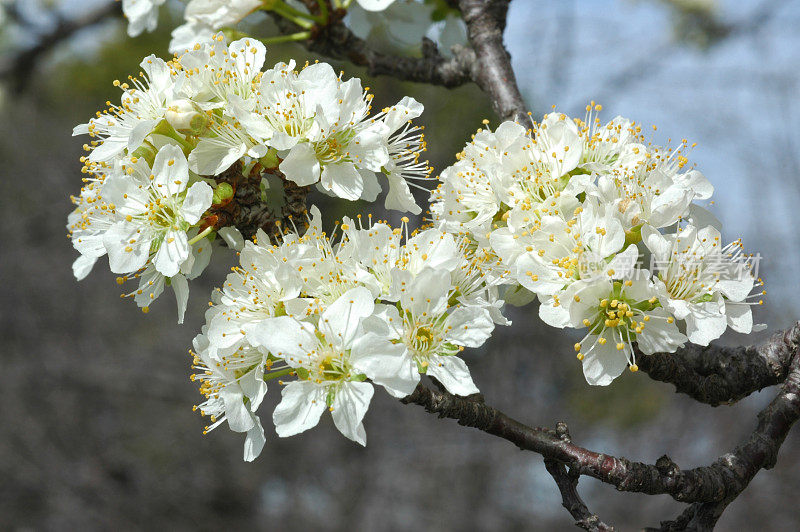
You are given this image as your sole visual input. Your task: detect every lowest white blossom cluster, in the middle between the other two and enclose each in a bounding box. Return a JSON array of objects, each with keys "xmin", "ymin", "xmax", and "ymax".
[{"xmin": 193, "ymin": 208, "xmax": 507, "ymax": 460}]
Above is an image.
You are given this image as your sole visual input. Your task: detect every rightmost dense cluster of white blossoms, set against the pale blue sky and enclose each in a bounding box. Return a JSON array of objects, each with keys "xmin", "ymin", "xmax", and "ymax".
[{"xmin": 431, "ymin": 103, "xmax": 764, "ymax": 385}]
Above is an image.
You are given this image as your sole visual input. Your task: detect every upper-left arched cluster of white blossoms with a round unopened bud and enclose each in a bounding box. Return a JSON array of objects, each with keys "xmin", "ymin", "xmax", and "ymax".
[{"xmin": 68, "ymin": 35, "xmax": 429, "ymax": 321}]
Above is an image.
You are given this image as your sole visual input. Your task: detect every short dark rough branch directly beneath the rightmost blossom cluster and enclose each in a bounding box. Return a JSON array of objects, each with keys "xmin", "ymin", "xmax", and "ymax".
[{"xmin": 637, "ymin": 322, "xmax": 800, "ymax": 406}]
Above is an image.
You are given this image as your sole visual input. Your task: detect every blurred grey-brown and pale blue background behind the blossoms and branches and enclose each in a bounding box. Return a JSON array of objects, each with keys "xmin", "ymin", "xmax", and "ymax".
[{"xmin": 0, "ymin": 0, "xmax": 800, "ymax": 530}]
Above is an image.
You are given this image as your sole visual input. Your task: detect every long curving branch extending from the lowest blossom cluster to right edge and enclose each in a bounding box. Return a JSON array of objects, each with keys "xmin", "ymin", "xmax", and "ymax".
[{"xmin": 403, "ymin": 324, "xmax": 800, "ymax": 508}]
